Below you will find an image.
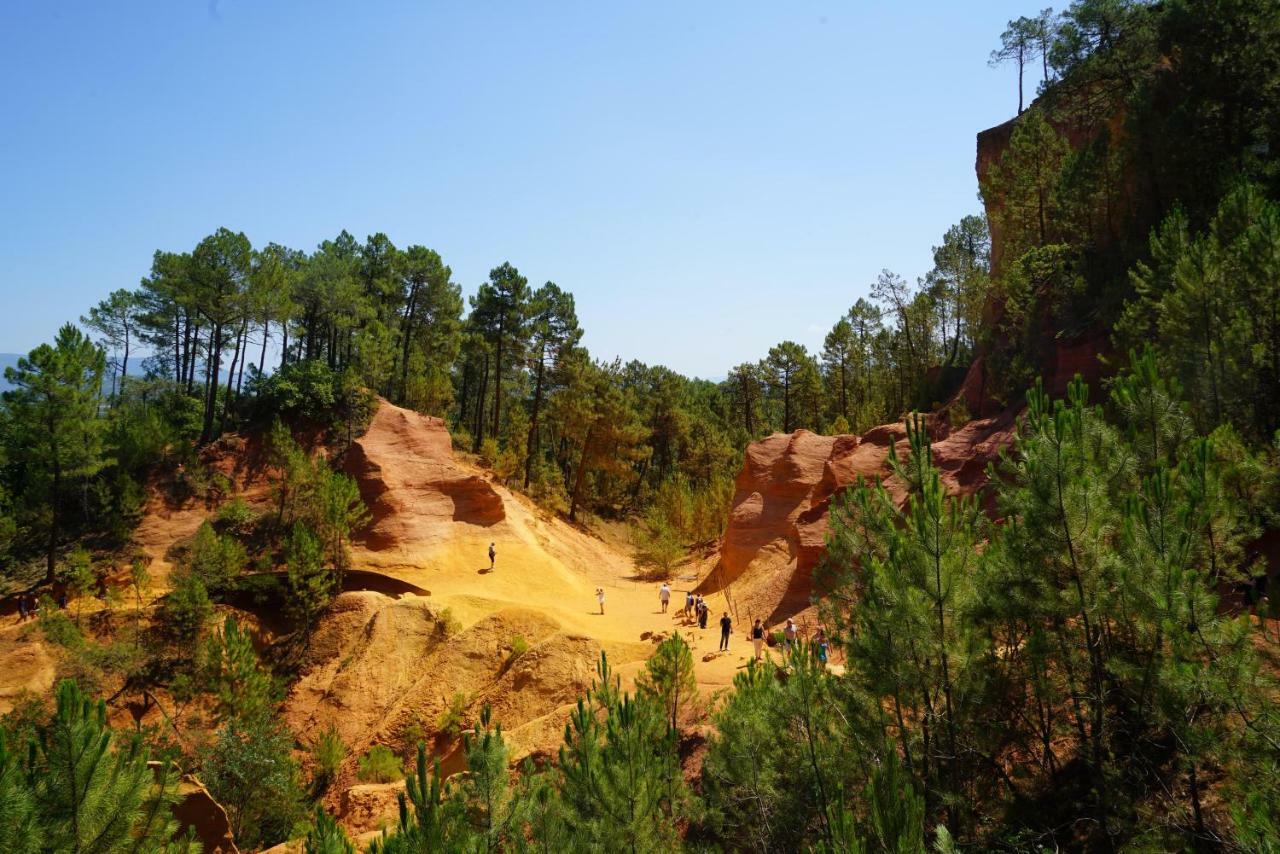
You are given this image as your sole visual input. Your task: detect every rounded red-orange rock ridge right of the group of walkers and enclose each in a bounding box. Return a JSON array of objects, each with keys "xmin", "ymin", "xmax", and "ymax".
[{"xmin": 700, "ymin": 412, "xmax": 1016, "ymax": 625}]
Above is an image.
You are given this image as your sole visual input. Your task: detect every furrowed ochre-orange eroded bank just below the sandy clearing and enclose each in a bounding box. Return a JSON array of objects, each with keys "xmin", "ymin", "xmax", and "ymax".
[{"xmin": 283, "ymin": 592, "xmax": 600, "ymax": 814}]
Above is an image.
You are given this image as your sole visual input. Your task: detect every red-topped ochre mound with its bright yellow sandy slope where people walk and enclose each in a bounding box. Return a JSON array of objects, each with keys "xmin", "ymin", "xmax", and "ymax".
[{"xmin": 347, "ymin": 402, "xmax": 750, "ymax": 690}]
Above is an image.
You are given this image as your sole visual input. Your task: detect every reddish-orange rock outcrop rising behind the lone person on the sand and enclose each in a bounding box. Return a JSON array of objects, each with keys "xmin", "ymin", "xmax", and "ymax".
[{"xmin": 346, "ymin": 401, "xmax": 506, "ymax": 552}]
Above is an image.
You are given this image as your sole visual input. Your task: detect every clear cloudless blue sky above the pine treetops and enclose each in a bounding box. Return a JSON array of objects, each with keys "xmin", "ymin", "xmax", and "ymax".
[{"xmin": 0, "ymin": 0, "xmax": 1038, "ymax": 378}]
